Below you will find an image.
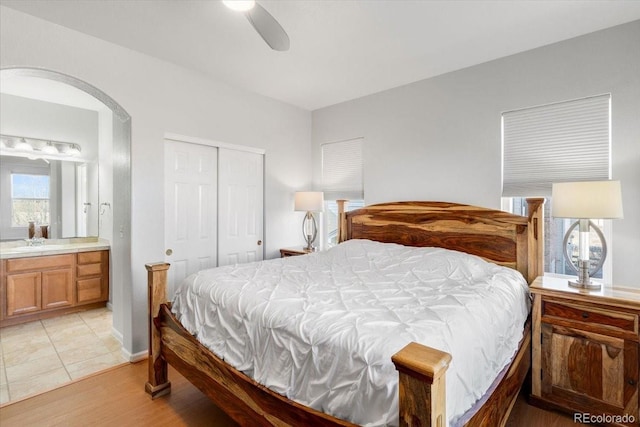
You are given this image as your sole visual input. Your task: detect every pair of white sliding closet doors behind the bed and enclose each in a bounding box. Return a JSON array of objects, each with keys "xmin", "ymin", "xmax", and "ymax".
[{"xmin": 165, "ymin": 140, "xmax": 264, "ymax": 298}]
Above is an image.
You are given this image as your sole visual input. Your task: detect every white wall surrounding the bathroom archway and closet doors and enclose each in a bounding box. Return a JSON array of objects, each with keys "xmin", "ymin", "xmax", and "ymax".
[{"xmin": 0, "ymin": 7, "xmax": 311, "ymax": 354}]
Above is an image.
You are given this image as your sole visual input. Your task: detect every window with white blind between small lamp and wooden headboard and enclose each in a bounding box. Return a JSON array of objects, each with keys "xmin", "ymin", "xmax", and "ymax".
[{"xmin": 321, "ymin": 138, "xmax": 364, "ymax": 247}]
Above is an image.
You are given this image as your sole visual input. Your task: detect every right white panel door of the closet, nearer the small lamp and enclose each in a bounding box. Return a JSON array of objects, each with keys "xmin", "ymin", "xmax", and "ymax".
[{"xmin": 218, "ymin": 148, "xmax": 264, "ymax": 265}]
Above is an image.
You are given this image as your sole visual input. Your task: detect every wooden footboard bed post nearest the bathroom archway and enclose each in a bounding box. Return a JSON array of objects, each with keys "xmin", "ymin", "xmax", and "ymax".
[{"xmin": 144, "ymin": 263, "xmax": 171, "ymax": 399}]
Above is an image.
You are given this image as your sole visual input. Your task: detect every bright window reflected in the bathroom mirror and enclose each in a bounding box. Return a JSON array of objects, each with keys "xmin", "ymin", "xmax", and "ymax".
[{"xmin": 11, "ymin": 173, "xmax": 49, "ymax": 227}]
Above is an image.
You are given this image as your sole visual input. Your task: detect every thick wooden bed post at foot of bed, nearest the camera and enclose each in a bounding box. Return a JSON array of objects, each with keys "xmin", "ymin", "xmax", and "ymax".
[{"xmin": 391, "ymin": 342, "xmax": 451, "ymax": 427}]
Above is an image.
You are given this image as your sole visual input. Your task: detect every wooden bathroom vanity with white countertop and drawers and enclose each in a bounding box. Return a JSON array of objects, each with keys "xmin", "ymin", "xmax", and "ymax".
[{"xmin": 0, "ymin": 238, "xmax": 109, "ymax": 327}]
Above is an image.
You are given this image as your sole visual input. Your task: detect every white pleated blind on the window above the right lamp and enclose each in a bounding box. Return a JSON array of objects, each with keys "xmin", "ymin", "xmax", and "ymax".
[{"xmin": 502, "ymin": 94, "xmax": 611, "ymax": 197}]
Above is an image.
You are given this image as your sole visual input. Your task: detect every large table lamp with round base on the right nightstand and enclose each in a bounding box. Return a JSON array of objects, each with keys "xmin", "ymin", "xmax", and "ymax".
[{"xmin": 551, "ymin": 181, "xmax": 622, "ymax": 289}]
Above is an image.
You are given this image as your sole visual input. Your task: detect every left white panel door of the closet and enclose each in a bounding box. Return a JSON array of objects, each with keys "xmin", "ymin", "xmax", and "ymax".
[{"xmin": 164, "ymin": 140, "xmax": 218, "ymax": 298}]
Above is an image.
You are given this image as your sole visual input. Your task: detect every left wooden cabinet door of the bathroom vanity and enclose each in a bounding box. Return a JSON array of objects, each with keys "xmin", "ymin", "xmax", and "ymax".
[{"xmin": 6, "ymin": 272, "xmax": 42, "ymax": 317}]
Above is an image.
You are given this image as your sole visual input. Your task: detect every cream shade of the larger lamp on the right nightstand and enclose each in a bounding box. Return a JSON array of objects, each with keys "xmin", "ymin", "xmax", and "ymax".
[{"xmin": 551, "ymin": 181, "xmax": 622, "ymax": 219}]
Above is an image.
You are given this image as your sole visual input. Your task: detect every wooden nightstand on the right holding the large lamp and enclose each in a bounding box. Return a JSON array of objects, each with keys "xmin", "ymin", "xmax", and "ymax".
[{"xmin": 530, "ymin": 276, "xmax": 640, "ymax": 426}]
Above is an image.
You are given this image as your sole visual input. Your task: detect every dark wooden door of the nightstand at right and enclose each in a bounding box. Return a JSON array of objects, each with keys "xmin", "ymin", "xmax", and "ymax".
[{"xmin": 541, "ymin": 323, "xmax": 638, "ymax": 425}]
